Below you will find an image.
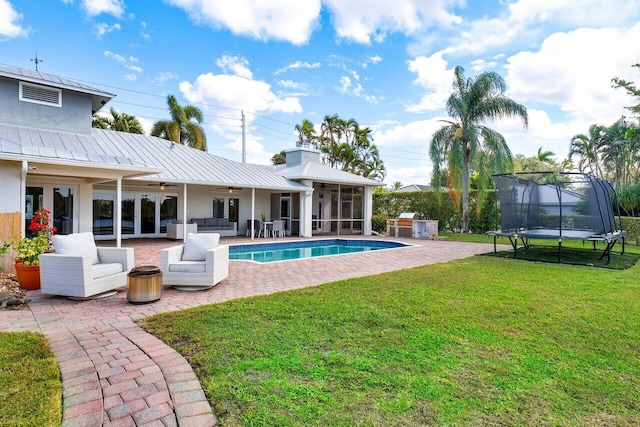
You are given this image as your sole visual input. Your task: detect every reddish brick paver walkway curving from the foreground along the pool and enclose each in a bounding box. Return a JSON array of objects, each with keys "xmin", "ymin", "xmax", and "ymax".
[{"xmin": 0, "ymin": 239, "xmax": 502, "ymax": 427}]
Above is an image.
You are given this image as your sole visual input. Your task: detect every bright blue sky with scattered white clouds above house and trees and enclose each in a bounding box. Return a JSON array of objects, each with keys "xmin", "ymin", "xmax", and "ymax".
[{"xmin": 0, "ymin": 0, "xmax": 640, "ymax": 185}]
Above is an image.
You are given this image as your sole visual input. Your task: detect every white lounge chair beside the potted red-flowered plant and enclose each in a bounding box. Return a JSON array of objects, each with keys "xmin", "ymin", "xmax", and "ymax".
[{"xmin": 39, "ymin": 233, "xmax": 134, "ymax": 298}]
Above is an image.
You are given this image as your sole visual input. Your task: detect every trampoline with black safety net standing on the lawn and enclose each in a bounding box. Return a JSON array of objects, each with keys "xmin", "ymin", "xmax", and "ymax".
[{"xmin": 487, "ymin": 172, "xmax": 627, "ymax": 264}]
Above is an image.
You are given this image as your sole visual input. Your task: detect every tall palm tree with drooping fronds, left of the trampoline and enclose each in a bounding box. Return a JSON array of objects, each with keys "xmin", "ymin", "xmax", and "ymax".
[{"xmin": 429, "ymin": 66, "xmax": 529, "ymax": 231}]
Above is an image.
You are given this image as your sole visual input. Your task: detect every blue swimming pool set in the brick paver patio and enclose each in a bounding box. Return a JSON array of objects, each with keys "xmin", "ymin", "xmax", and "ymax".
[{"xmin": 229, "ymin": 239, "xmax": 409, "ymax": 263}]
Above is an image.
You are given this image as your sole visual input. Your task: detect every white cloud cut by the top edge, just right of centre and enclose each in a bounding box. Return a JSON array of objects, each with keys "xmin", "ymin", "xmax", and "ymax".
[{"xmin": 323, "ymin": 0, "xmax": 461, "ymax": 44}]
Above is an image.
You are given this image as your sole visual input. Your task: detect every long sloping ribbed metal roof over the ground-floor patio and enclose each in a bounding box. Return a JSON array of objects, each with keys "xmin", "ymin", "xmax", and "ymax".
[{"xmin": 0, "ymin": 125, "xmax": 309, "ymax": 191}]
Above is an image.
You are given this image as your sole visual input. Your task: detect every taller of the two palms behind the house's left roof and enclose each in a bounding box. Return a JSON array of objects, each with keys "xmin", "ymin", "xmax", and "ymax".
[{"xmin": 151, "ymin": 95, "xmax": 207, "ymax": 151}]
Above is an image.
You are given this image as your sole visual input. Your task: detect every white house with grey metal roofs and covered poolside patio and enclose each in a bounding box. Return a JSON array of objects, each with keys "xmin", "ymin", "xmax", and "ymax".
[{"xmin": 0, "ymin": 66, "xmax": 382, "ymax": 254}]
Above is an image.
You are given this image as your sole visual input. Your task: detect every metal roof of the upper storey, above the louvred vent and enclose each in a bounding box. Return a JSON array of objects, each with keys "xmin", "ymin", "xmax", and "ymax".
[{"xmin": 0, "ymin": 64, "xmax": 115, "ymax": 113}]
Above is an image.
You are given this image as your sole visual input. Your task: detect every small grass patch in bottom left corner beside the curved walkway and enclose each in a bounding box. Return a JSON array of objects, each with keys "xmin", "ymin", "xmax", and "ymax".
[{"xmin": 0, "ymin": 332, "xmax": 62, "ymax": 427}]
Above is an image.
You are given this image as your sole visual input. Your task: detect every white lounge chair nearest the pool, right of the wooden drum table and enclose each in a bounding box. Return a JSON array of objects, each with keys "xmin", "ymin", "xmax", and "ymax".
[{"xmin": 160, "ymin": 233, "xmax": 229, "ymax": 291}]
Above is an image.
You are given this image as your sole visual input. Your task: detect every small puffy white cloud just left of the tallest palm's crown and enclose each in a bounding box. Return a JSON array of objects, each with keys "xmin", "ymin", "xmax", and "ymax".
[{"xmin": 407, "ymin": 51, "xmax": 453, "ymax": 113}]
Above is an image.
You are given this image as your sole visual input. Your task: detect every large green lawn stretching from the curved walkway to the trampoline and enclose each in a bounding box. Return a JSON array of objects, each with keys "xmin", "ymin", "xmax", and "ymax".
[{"xmin": 141, "ymin": 256, "xmax": 640, "ymax": 426}]
